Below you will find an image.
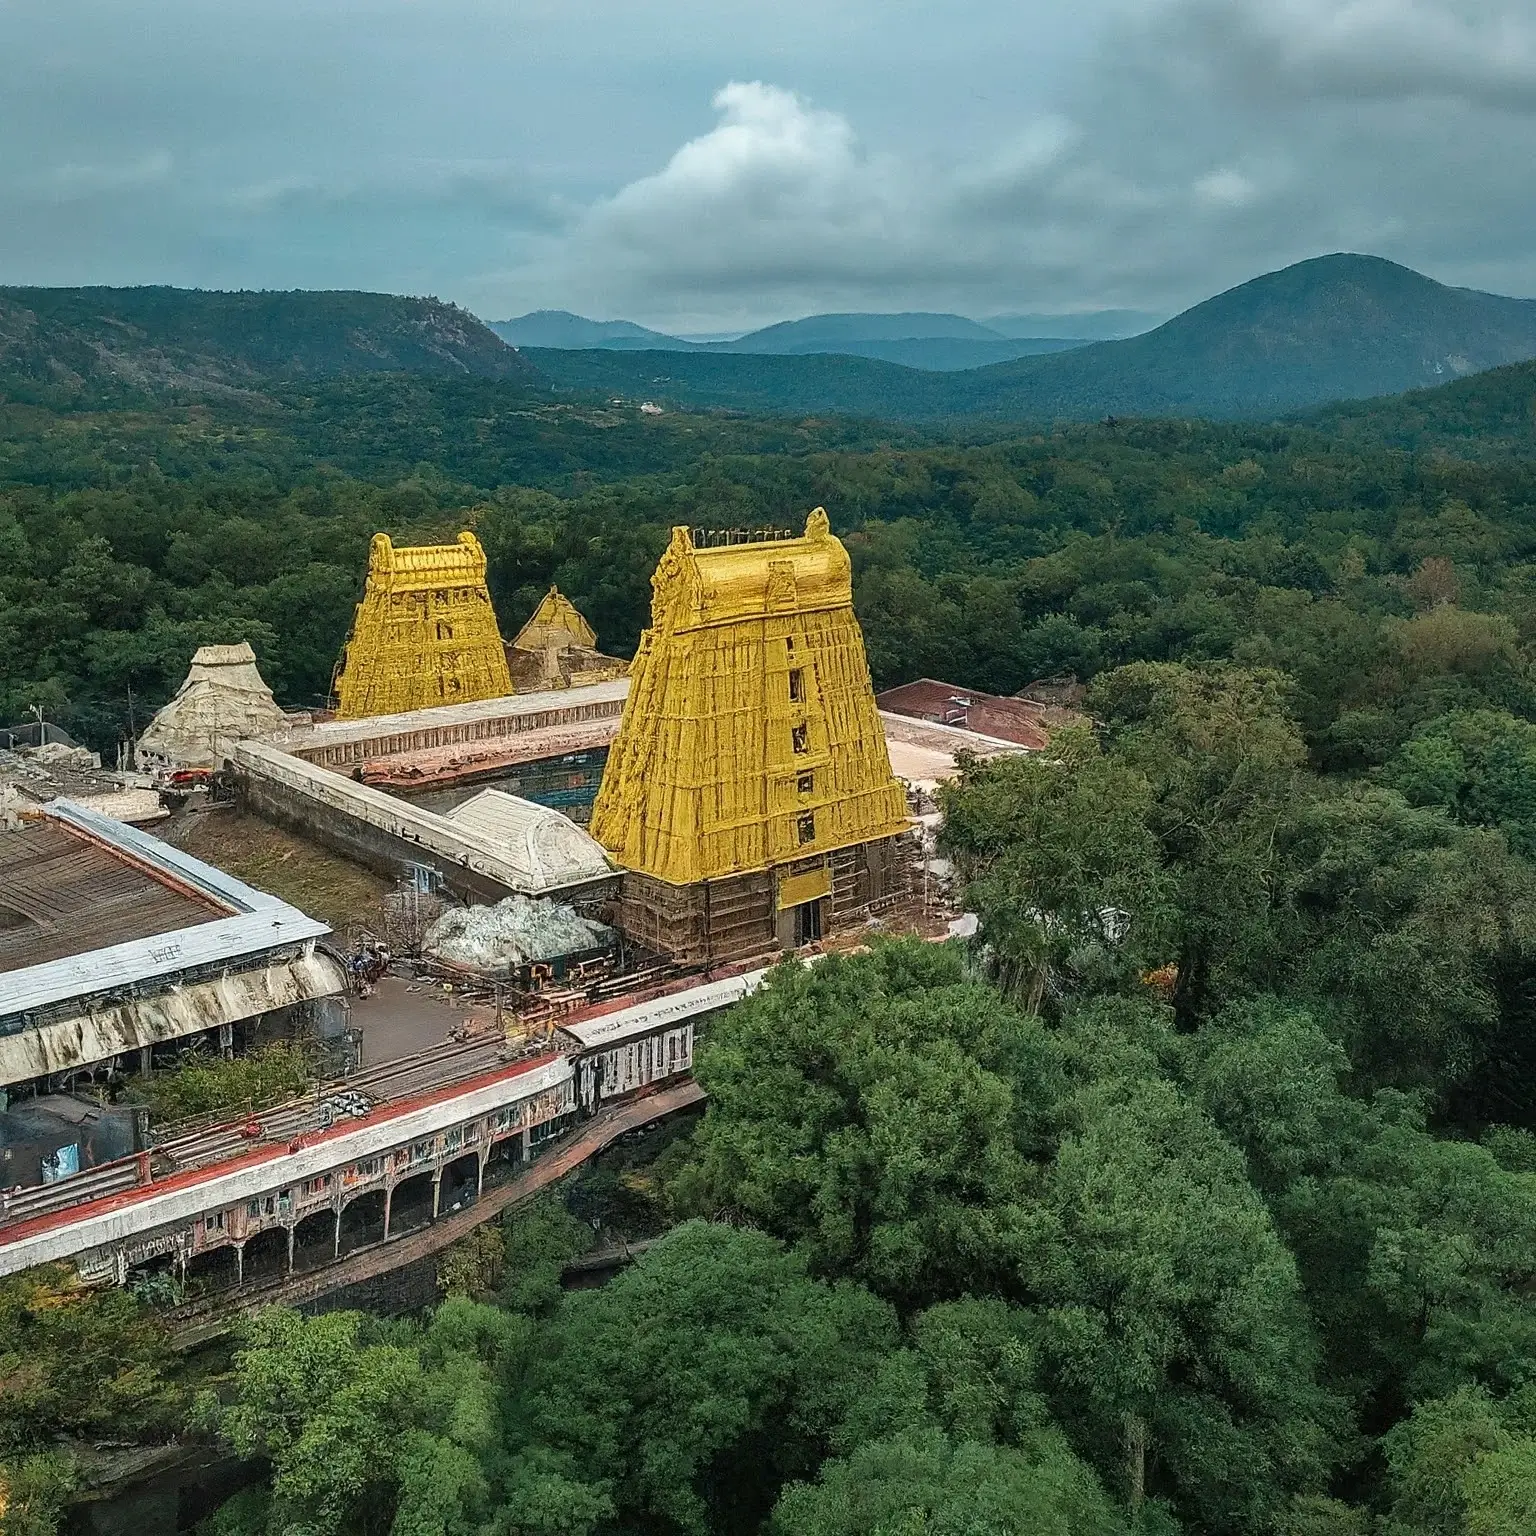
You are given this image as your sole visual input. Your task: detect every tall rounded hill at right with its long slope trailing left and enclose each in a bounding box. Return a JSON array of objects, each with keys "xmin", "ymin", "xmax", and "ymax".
[{"xmin": 541, "ymin": 255, "xmax": 1536, "ymax": 421}]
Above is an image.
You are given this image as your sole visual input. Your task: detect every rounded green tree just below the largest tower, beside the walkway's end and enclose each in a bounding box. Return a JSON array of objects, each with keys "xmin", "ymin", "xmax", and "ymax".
[{"xmin": 676, "ymin": 945, "xmax": 1058, "ymax": 1304}]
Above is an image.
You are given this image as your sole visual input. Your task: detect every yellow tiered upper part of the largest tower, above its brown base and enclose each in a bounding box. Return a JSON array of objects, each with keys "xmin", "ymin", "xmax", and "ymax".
[{"xmin": 591, "ymin": 507, "xmax": 911, "ymax": 890}]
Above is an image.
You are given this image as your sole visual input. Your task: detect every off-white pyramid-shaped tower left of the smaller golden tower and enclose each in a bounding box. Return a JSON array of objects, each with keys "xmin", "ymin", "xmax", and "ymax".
[{"xmin": 138, "ymin": 641, "xmax": 287, "ymax": 768}]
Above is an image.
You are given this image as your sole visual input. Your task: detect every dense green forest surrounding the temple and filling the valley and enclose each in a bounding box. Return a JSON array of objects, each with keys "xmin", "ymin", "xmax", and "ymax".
[{"xmin": 0, "ymin": 369, "xmax": 1536, "ymax": 1536}]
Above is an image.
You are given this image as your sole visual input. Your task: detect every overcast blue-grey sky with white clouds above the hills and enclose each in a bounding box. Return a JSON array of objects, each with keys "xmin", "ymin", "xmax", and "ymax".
[{"xmin": 0, "ymin": 0, "xmax": 1536, "ymax": 330}]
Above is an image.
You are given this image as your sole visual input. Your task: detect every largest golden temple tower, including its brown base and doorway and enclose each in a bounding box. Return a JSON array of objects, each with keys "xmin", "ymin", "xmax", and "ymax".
[{"xmin": 591, "ymin": 508, "xmax": 915, "ymax": 963}]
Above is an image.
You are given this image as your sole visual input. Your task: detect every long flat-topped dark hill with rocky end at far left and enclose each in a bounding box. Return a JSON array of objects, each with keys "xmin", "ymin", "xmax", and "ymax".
[{"xmin": 0, "ymin": 287, "xmax": 541, "ymax": 401}]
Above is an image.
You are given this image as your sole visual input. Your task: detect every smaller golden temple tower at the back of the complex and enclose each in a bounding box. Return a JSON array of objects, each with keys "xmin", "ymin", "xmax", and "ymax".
[{"xmin": 332, "ymin": 533, "xmax": 511, "ymax": 720}]
